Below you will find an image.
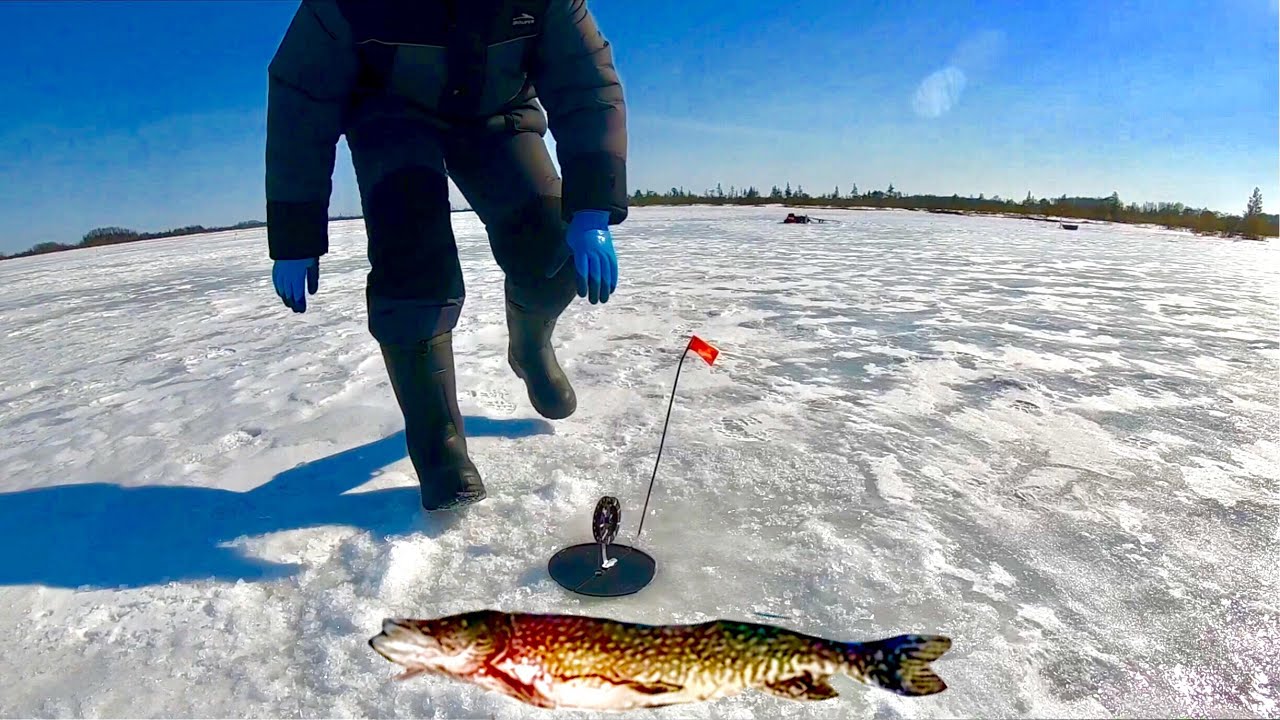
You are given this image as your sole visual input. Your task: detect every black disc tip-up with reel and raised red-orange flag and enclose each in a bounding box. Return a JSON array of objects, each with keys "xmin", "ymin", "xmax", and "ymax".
[{"xmin": 547, "ymin": 336, "xmax": 719, "ymax": 597}]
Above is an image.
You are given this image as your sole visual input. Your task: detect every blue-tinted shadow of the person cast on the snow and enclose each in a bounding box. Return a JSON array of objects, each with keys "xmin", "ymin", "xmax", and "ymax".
[{"xmin": 0, "ymin": 416, "xmax": 552, "ymax": 588}]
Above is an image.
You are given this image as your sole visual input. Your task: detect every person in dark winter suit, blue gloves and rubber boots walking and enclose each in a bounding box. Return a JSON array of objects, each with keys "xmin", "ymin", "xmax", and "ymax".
[{"xmin": 259, "ymin": 0, "xmax": 627, "ymax": 510}]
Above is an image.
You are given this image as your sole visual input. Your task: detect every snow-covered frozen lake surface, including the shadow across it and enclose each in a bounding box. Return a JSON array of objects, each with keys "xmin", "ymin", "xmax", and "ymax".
[{"xmin": 0, "ymin": 208, "xmax": 1280, "ymax": 717}]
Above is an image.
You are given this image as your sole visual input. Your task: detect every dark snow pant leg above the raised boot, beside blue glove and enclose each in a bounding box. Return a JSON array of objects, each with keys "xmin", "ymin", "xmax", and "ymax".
[{"xmin": 445, "ymin": 124, "xmax": 577, "ymax": 316}]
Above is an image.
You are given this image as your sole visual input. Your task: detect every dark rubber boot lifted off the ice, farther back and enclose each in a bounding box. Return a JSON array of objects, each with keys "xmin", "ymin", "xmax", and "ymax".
[{"xmin": 507, "ymin": 300, "xmax": 577, "ymax": 420}]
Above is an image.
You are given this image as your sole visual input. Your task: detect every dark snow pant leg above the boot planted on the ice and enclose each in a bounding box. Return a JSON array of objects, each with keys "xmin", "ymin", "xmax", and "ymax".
[{"xmin": 347, "ymin": 115, "xmax": 466, "ymax": 345}]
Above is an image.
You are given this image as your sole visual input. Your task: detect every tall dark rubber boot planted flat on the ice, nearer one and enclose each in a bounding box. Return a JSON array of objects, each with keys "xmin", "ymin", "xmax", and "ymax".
[{"xmin": 381, "ymin": 333, "xmax": 486, "ymax": 510}]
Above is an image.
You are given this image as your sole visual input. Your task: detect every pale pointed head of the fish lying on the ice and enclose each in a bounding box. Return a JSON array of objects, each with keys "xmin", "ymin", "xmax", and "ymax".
[{"xmin": 369, "ymin": 611, "xmax": 500, "ymax": 675}]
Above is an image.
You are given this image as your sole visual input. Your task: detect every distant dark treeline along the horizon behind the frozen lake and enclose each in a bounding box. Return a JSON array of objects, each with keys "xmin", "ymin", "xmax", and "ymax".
[{"xmin": 0, "ymin": 183, "xmax": 1280, "ymax": 260}]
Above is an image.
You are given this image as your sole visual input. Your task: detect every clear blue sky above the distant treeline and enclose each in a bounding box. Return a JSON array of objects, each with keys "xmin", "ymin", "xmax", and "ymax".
[{"xmin": 0, "ymin": 0, "xmax": 1280, "ymax": 252}]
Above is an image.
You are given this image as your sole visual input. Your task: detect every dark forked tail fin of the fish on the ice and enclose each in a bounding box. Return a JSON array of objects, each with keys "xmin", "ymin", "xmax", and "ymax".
[{"xmin": 845, "ymin": 635, "xmax": 951, "ymax": 696}]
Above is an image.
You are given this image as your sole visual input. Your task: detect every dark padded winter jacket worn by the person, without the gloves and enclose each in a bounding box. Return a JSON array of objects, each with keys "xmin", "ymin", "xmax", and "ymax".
[{"xmin": 266, "ymin": 0, "xmax": 627, "ymax": 259}]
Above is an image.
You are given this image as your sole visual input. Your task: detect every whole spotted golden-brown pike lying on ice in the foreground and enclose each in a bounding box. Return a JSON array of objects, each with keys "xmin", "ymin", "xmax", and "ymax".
[{"xmin": 369, "ymin": 610, "xmax": 951, "ymax": 711}]
